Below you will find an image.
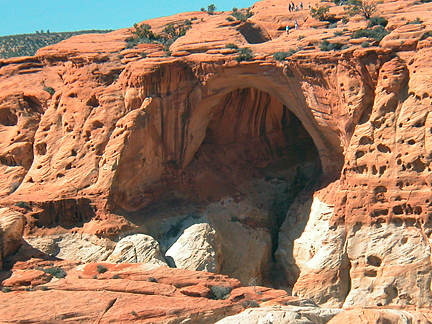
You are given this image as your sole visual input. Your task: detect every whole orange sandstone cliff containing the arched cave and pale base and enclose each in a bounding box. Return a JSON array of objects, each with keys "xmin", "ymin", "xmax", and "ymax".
[{"xmin": 0, "ymin": 0, "xmax": 432, "ymax": 323}]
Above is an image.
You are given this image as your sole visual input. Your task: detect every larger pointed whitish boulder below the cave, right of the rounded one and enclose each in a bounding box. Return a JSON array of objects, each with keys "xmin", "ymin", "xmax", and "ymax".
[{"xmin": 165, "ymin": 223, "xmax": 220, "ymax": 272}]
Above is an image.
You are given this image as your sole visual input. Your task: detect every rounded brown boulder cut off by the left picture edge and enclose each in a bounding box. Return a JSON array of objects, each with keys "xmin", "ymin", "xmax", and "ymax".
[{"xmin": 0, "ymin": 208, "xmax": 26, "ymax": 269}]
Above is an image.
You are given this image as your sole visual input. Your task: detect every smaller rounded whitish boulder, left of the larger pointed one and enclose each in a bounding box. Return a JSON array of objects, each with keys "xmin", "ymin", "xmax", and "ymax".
[{"xmin": 107, "ymin": 234, "xmax": 167, "ymax": 266}]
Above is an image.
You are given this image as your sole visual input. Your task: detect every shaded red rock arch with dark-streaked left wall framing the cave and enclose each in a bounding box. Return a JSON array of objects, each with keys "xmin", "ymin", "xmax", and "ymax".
[{"xmin": 104, "ymin": 63, "xmax": 343, "ymax": 211}]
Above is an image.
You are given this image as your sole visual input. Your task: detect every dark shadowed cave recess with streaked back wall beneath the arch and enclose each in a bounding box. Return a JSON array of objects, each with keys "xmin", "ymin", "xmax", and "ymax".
[{"xmin": 184, "ymin": 87, "xmax": 322, "ymax": 286}]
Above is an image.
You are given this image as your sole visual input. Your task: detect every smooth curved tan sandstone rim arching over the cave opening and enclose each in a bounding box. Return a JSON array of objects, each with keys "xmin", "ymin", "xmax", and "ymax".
[{"xmin": 183, "ymin": 64, "xmax": 343, "ymax": 184}]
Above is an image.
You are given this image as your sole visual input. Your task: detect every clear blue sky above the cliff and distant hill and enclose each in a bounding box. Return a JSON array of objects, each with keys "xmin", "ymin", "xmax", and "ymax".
[{"xmin": 0, "ymin": 0, "xmax": 257, "ymax": 36}]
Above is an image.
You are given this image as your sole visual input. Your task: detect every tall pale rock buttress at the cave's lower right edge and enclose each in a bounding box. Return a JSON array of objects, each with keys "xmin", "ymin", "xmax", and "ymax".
[{"xmin": 276, "ymin": 197, "xmax": 350, "ymax": 307}]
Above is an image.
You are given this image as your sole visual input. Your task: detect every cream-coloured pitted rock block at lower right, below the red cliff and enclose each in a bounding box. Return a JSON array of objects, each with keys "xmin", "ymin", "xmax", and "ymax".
[{"xmin": 344, "ymin": 223, "xmax": 432, "ymax": 307}]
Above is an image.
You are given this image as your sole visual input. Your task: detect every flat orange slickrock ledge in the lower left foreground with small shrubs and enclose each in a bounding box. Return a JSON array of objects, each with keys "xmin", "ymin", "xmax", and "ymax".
[{"xmin": 0, "ymin": 260, "xmax": 290, "ymax": 324}]
